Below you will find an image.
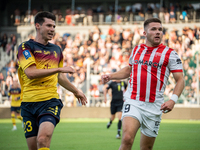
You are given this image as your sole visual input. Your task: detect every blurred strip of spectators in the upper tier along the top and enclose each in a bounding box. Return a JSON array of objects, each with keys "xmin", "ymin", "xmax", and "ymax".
[{"xmin": 13, "ymin": 3, "xmax": 200, "ymax": 25}]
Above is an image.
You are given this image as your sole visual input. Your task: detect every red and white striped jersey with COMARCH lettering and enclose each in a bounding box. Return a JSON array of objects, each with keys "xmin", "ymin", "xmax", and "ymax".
[{"xmin": 124, "ymin": 44, "xmax": 183, "ymax": 103}]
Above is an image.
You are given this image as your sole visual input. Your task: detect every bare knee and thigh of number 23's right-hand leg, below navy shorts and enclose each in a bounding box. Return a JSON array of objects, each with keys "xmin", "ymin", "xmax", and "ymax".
[{"xmin": 37, "ymin": 121, "xmax": 54, "ymax": 148}]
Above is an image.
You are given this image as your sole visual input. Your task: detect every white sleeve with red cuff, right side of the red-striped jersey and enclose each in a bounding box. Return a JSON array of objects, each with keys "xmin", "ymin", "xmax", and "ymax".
[{"xmin": 168, "ymin": 50, "xmax": 183, "ymax": 73}]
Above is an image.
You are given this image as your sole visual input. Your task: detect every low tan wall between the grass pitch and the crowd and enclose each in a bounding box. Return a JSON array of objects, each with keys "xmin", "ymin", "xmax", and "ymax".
[{"xmin": 0, "ymin": 107, "xmax": 200, "ymax": 120}]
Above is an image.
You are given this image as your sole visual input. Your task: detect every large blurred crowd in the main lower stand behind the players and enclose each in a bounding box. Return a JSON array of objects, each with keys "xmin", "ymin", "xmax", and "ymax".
[{"xmin": 0, "ymin": 22, "xmax": 200, "ymax": 107}]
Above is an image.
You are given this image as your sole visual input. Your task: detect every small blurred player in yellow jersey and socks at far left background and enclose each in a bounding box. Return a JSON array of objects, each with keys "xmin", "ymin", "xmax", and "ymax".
[{"xmin": 8, "ymin": 80, "xmax": 22, "ymax": 131}]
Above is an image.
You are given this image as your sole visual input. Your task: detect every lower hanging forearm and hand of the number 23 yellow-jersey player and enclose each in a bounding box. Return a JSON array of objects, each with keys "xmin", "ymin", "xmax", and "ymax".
[{"xmin": 58, "ymin": 73, "xmax": 87, "ymax": 105}]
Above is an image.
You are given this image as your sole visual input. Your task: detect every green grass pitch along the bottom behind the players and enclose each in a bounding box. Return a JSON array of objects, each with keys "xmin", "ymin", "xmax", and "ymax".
[{"xmin": 0, "ymin": 119, "xmax": 200, "ymax": 150}]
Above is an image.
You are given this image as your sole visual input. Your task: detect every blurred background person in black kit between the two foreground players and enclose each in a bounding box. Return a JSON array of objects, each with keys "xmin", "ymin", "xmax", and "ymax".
[{"xmin": 104, "ymin": 74, "xmax": 127, "ymax": 139}]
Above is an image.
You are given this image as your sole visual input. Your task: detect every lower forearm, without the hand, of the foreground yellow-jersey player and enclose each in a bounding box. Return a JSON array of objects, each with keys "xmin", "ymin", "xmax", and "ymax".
[{"xmin": 58, "ymin": 73, "xmax": 78, "ymax": 93}]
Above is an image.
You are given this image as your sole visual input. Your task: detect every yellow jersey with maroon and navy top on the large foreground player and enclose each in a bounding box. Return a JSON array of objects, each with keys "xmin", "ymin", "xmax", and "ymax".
[{"xmin": 17, "ymin": 39, "xmax": 63, "ymax": 102}]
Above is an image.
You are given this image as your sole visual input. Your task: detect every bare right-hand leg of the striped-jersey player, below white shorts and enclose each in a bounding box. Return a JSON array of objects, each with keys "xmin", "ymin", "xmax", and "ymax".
[{"xmin": 140, "ymin": 133, "xmax": 156, "ymax": 150}]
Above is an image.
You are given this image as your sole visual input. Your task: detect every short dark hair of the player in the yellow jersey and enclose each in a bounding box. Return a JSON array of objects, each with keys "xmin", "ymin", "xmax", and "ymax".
[{"xmin": 34, "ymin": 11, "xmax": 56, "ymax": 25}]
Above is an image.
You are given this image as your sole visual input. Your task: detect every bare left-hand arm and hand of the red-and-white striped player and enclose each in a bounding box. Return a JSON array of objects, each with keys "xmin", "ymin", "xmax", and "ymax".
[{"xmin": 101, "ymin": 66, "xmax": 131, "ymax": 84}]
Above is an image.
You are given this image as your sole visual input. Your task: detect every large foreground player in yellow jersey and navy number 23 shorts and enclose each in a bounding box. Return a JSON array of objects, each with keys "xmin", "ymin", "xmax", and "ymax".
[{"xmin": 17, "ymin": 11, "xmax": 87, "ymax": 150}]
